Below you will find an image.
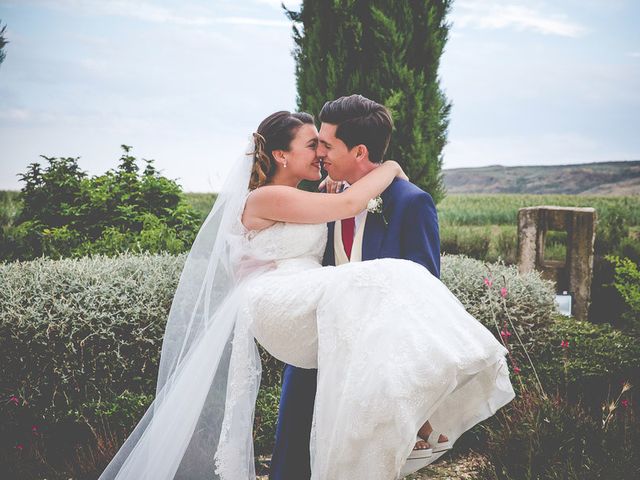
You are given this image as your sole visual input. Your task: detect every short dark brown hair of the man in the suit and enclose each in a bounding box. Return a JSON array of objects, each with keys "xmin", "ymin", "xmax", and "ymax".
[{"xmin": 319, "ymin": 94, "xmax": 393, "ymax": 163}]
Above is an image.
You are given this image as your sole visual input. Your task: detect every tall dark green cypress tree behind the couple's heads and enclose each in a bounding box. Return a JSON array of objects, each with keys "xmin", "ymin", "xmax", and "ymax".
[{"xmin": 286, "ymin": 0, "xmax": 451, "ymax": 202}]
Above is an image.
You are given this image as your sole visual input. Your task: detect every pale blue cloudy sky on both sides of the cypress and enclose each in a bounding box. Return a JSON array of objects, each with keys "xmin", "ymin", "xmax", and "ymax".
[{"xmin": 0, "ymin": 0, "xmax": 640, "ymax": 192}]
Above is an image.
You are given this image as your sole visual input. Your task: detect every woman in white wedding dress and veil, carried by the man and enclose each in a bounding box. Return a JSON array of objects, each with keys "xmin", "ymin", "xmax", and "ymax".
[{"xmin": 100, "ymin": 112, "xmax": 515, "ymax": 480}]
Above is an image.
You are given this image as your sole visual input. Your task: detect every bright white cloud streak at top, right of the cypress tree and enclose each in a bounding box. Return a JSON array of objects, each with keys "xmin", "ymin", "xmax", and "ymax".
[{"xmin": 452, "ymin": 0, "xmax": 587, "ymax": 38}]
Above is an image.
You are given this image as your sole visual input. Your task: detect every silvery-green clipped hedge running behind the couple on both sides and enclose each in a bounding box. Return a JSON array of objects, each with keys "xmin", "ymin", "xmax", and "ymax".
[{"xmin": 0, "ymin": 254, "xmax": 553, "ymax": 462}]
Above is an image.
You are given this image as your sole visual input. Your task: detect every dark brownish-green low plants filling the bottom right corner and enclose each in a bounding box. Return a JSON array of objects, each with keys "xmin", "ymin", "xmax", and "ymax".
[{"xmin": 483, "ymin": 389, "xmax": 640, "ymax": 480}]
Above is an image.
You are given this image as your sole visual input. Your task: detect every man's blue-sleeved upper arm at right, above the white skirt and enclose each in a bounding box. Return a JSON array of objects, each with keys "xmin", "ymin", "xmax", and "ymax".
[{"xmin": 401, "ymin": 192, "xmax": 440, "ymax": 278}]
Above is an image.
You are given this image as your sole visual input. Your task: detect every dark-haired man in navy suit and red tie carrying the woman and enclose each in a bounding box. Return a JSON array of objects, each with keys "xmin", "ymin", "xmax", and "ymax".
[{"xmin": 269, "ymin": 95, "xmax": 440, "ymax": 480}]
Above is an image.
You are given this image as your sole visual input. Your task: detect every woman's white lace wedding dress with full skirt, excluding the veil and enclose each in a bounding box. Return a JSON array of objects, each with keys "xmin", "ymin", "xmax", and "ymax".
[{"xmin": 241, "ymin": 219, "xmax": 515, "ymax": 480}]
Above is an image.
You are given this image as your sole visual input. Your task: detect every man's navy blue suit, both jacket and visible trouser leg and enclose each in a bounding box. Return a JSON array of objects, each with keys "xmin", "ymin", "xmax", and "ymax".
[{"xmin": 269, "ymin": 178, "xmax": 440, "ymax": 480}]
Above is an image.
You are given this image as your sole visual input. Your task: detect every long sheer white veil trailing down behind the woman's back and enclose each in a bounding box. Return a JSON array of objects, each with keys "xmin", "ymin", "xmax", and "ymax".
[{"xmin": 99, "ymin": 141, "xmax": 264, "ymax": 480}]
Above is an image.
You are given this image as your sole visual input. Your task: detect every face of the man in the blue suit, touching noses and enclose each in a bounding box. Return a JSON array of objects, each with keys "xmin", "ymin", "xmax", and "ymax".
[{"xmin": 316, "ymin": 122, "xmax": 357, "ymax": 183}]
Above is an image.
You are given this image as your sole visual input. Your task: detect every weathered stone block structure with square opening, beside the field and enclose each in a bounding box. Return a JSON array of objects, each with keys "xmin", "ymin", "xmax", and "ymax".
[{"xmin": 518, "ymin": 206, "xmax": 597, "ymax": 320}]
